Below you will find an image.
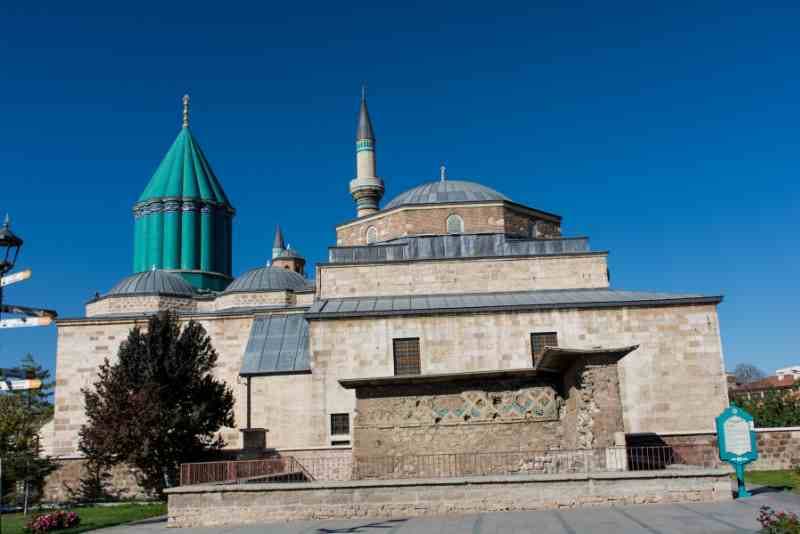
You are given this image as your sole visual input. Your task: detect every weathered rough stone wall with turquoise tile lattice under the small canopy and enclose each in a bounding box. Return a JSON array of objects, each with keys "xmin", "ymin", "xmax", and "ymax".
[{"xmin": 353, "ymin": 379, "xmax": 562, "ymax": 461}]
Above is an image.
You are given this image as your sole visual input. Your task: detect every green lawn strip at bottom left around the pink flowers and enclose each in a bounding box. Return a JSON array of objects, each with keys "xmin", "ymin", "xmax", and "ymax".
[{"xmin": 0, "ymin": 503, "xmax": 167, "ymax": 534}]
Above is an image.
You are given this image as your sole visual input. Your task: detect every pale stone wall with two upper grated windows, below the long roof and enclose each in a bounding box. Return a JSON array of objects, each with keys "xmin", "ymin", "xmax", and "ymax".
[{"xmin": 310, "ymin": 305, "xmax": 727, "ymax": 445}]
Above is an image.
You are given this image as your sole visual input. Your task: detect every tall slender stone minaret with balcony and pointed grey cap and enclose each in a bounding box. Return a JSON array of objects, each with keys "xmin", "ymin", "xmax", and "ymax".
[{"xmin": 350, "ymin": 86, "xmax": 383, "ymax": 217}]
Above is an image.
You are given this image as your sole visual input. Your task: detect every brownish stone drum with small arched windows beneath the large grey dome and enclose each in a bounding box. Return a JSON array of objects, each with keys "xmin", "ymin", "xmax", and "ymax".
[{"xmin": 336, "ymin": 202, "xmax": 561, "ymax": 246}]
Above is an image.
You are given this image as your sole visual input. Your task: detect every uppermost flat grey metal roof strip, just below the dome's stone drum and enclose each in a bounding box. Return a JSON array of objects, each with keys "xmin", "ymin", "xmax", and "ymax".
[{"xmin": 328, "ymin": 234, "xmax": 589, "ymax": 263}]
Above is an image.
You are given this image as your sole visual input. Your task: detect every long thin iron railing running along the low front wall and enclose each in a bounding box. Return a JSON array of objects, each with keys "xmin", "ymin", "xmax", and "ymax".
[{"xmin": 181, "ymin": 445, "xmax": 721, "ymax": 485}]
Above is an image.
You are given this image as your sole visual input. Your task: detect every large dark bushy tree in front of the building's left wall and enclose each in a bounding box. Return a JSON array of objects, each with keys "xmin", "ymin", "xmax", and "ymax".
[{"xmin": 79, "ymin": 313, "xmax": 234, "ymax": 496}]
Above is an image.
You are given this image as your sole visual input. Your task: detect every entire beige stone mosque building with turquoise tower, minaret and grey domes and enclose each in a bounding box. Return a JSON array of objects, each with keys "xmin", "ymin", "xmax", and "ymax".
[{"xmin": 48, "ymin": 91, "xmax": 727, "ymax": 498}]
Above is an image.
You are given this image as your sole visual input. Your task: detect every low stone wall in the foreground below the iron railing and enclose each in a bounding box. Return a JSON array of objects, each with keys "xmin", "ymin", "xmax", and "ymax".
[{"xmin": 167, "ymin": 469, "xmax": 732, "ymax": 527}]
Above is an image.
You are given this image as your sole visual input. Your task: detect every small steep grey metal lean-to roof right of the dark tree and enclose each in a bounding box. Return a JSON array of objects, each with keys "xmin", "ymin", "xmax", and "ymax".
[{"xmin": 239, "ymin": 313, "xmax": 311, "ymax": 376}]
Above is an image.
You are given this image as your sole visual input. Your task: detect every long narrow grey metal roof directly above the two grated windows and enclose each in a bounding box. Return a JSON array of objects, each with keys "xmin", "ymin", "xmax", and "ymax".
[{"xmin": 306, "ymin": 289, "xmax": 722, "ymax": 319}]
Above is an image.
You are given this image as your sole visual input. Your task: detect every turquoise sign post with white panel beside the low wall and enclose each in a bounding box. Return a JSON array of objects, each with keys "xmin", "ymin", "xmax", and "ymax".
[{"xmin": 716, "ymin": 406, "xmax": 758, "ymax": 499}]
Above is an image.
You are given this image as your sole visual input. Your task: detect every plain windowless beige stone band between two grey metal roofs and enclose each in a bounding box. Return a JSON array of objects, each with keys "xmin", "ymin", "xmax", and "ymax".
[{"xmin": 318, "ymin": 253, "xmax": 608, "ymax": 299}]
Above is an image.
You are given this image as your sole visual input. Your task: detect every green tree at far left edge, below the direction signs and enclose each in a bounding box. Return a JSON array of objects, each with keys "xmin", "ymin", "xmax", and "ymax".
[{"xmin": 0, "ymin": 354, "xmax": 57, "ymax": 504}]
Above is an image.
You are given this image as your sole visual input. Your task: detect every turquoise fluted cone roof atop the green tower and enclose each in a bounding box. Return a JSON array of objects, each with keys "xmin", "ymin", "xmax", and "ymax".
[{"xmin": 139, "ymin": 128, "xmax": 230, "ymax": 206}]
